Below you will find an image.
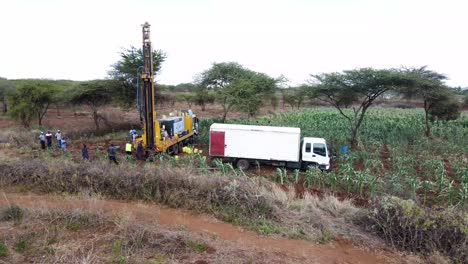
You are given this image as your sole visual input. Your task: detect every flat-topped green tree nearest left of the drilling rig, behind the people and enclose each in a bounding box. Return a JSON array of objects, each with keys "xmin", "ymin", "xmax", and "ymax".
[{"xmin": 70, "ymin": 80, "xmax": 120, "ymax": 131}]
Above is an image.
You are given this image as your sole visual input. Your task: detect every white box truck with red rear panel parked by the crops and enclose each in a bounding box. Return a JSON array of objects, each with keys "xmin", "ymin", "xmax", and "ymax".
[{"xmin": 210, "ymin": 123, "xmax": 330, "ymax": 170}]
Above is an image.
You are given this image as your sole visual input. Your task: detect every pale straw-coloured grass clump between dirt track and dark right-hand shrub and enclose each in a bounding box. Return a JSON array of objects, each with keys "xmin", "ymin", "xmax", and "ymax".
[{"xmin": 262, "ymin": 184, "xmax": 374, "ymax": 244}]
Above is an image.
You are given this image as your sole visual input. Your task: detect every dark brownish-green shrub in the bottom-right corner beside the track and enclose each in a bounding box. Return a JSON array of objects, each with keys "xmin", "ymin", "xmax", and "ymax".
[{"xmin": 367, "ymin": 197, "xmax": 468, "ymax": 263}]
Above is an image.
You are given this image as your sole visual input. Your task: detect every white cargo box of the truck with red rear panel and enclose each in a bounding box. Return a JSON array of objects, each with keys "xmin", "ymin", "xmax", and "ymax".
[{"xmin": 210, "ymin": 124, "xmax": 301, "ymax": 162}]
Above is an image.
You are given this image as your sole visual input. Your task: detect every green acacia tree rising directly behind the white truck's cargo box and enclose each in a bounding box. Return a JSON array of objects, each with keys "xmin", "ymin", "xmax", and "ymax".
[{"xmin": 198, "ymin": 62, "xmax": 277, "ymax": 122}]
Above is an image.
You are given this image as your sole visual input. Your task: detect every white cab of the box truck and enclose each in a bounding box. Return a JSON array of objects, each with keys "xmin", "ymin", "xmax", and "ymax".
[{"xmin": 301, "ymin": 137, "xmax": 330, "ymax": 170}]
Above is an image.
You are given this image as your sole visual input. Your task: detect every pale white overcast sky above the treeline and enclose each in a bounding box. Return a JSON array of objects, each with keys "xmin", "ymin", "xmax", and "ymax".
[{"xmin": 0, "ymin": 0, "xmax": 468, "ymax": 87}]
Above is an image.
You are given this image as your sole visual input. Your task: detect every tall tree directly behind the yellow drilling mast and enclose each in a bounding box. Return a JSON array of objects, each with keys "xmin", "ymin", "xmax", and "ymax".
[{"xmin": 109, "ymin": 46, "xmax": 166, "ymax": 107}]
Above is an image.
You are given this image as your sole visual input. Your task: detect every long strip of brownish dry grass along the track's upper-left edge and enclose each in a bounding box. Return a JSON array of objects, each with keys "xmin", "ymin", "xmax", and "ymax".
[{"xmin": 0, "ymin": 159, "xmax": 275, "ymax": 227}]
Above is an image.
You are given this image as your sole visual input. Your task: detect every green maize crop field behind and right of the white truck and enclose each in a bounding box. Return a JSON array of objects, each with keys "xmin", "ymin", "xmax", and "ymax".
[{"xmin": 201, "ymin": 108, "xmax": 468, "ymax": 206}]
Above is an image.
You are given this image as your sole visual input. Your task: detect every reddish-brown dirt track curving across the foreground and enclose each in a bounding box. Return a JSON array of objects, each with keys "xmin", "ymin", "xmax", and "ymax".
[{"xmin": 0, "ymin": 191, "xmax": 405, "ymax": 264}]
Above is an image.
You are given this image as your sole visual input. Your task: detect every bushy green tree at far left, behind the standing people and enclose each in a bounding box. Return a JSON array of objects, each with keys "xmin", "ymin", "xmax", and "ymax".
[{"xmin": 7, "ymin": 80, "xmax": 59, "ymax": 127}]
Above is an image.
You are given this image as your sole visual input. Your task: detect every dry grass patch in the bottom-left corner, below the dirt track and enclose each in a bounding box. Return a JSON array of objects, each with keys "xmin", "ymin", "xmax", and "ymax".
[{"xmin": 0, "ymin": 201, "xmax": 304, "ymax": 263}]
